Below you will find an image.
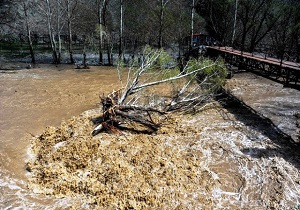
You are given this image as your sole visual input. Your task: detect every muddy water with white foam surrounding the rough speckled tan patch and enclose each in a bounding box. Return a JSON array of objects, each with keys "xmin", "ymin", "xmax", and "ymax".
[{"xmin": 0, "ymin": 65, "xmax": 300, "ymax": 209}]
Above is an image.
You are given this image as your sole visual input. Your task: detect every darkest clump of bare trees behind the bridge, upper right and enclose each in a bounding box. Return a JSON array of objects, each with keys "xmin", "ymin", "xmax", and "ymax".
[{"xmin": 196, "ymin": 0, "xmax": 300, "ymax": 61}]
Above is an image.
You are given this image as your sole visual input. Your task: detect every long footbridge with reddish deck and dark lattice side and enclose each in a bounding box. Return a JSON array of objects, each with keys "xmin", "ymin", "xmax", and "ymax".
[{"xmin": 207, "ymin": 46, "xmax": 300, "ymax": 86}]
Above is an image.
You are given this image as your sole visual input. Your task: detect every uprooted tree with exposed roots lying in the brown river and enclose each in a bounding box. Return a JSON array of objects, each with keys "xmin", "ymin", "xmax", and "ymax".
[{"xmin": 92, "ymin": 47, "xmax": 227, "ymax": 135}]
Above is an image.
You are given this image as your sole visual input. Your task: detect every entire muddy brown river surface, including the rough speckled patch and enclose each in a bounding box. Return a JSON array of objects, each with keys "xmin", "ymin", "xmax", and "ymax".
[{"xmin": 0, "ymin": 67, "xmax": 300, "ymax": 209}]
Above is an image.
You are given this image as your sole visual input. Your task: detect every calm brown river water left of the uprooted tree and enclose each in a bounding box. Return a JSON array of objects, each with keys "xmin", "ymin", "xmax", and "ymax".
[{"xmin": 0, "ymin": 65, "xmax": 122, "ymax": 209}]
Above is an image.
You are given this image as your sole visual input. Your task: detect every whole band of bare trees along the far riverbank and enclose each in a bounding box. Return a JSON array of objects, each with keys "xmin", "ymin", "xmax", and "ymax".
[{"xmin": 0, "ymin": 0, "xmax": 300, "ymax": 64}]
